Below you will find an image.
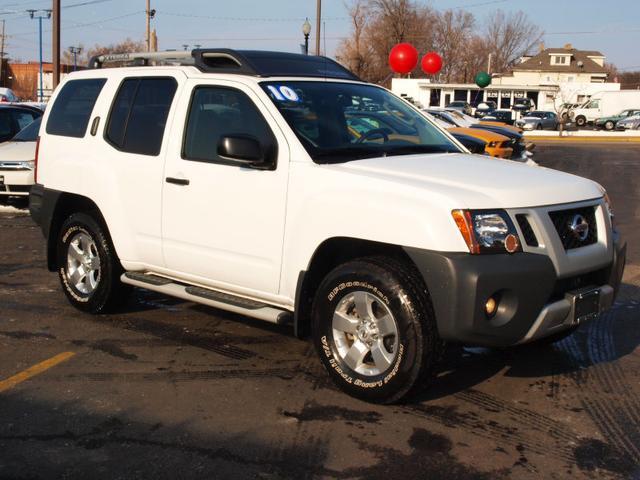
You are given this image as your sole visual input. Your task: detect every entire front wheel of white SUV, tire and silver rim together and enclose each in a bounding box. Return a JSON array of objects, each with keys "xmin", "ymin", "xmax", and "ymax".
[{"xmin": 312, "ymin": 257, "xmax": 443, "ymax": 403}]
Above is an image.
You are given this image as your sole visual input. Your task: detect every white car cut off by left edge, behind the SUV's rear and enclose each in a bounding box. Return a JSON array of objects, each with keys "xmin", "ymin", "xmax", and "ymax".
[{"xmin": 0, "ymin": 118, "xmax": 41, "ymax": 197}]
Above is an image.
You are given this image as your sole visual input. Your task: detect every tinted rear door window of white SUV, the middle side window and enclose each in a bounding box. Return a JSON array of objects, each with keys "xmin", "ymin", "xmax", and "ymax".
[{"xmin": 105, "ymin": 77, "xmax": 177, "ymax": 155}]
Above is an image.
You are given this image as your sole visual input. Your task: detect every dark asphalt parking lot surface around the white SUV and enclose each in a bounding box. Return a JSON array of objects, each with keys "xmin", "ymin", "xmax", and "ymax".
[{"xmin": 0, "ymin": 143, "xmax": 640, "ymax": 480}]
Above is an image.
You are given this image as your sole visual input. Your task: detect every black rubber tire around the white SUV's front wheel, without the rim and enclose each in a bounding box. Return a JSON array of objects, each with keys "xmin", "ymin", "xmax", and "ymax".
[{"xmin": 312, "ymin": 257, "xmax": 444, "ymax": 403}]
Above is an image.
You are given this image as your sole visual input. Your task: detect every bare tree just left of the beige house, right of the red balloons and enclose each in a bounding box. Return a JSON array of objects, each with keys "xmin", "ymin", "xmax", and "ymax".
[{"xmin": 486, "ymin": 10, "xmax": 543, "ymax": 72}]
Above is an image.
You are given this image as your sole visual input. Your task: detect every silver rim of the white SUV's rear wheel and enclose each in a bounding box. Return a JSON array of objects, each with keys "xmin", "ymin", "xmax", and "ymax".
[{"xmin": 66, "ymin": 232, "xmax": 100, "ymax": 295}]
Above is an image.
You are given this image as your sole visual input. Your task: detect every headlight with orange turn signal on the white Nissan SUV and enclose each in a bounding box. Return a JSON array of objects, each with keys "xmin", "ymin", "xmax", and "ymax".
[{"xmin": 451, "ymin": 210, "xmax": 522, "ymax": 254}]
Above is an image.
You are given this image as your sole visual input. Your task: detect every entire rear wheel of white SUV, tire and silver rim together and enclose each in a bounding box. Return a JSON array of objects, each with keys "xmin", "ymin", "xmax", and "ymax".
[{"xmin": 57, "ymin": 213, "xmax": 131, "ymax": 313}]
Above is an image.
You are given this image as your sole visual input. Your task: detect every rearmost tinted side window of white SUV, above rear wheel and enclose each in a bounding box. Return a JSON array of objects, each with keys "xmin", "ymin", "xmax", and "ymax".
[{"xmin": 47, "ymin": 78, "xmax": 107, "ymax": 138}]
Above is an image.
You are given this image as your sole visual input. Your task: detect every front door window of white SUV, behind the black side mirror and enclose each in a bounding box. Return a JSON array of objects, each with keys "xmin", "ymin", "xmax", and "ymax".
[{"xmin": 183, "ymin": 87, "xmax": 276, "ymax": 164}]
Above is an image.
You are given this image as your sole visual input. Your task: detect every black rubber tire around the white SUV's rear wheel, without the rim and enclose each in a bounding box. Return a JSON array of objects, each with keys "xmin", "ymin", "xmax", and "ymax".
[{"xmin": 57, "ymin": 213, "xmax": 131, "ymax": 314}]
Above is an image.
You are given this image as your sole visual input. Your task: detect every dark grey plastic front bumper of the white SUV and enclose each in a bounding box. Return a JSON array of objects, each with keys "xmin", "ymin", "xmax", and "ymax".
[{"xmin": 405, "ymin": 234, "xmax": 626, "ymax": 346}]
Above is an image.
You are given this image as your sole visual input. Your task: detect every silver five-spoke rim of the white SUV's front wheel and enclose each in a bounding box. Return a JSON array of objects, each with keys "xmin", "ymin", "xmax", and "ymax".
[{"xmin": 332, "ymin": 290, "xmax": 398, "ymax": 376}]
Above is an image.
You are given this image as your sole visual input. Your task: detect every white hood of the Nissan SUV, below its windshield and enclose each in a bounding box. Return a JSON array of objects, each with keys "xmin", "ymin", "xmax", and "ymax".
[{"xmin": 330, "ymin": 153, "xmax": 603, "ymax": 209}]
